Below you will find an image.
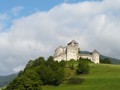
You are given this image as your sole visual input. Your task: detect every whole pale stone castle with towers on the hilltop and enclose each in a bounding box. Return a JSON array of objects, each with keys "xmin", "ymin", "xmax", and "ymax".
[{"xmin": 54, "ymin": 40, "xmax": 100, "ymax": 64}]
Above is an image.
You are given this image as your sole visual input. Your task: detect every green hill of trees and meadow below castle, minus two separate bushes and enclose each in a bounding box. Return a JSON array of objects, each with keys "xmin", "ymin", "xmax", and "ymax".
[{"xmin": 5, "ymin": 57, "xmax": 120, "ymax": 90}]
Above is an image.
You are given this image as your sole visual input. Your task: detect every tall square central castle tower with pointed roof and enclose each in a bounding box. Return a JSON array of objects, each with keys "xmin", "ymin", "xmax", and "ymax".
[{"xmin": 66, "ymin": 40, "xmax": 79, "ymax": 61}]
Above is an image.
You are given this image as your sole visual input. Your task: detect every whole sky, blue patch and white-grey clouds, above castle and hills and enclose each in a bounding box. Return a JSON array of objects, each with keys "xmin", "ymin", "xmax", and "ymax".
[{"xmin": 0, "ymin": 0, "xmax": 120, "ymax": 75}]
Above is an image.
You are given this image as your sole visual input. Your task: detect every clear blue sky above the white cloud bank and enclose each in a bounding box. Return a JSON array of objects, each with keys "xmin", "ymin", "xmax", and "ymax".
[{"xmin": 0, "ymin": 0, "xmax": 89, "ymax": 31}]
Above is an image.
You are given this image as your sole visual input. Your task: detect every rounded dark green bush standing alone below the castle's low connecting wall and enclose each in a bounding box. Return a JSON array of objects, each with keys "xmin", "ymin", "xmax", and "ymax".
[{"xmin": 76, "ymin": 58, "xmax": 90, "ymax": 75}]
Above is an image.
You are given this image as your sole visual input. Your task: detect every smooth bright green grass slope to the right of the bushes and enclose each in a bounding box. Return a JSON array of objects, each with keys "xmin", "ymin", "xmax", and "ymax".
[{"xmin": 42, "ymin": 64, "xmax": 120, "ymax": 90}]
